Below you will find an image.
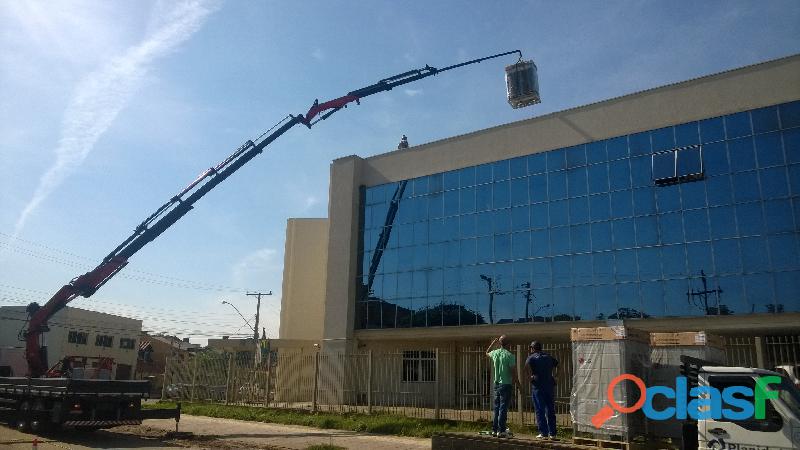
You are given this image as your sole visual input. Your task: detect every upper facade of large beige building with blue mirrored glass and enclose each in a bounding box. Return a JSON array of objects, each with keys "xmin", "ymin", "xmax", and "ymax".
[{"xmin": 281, "ymin": 51, "xmax": 800, "ymax": 349}]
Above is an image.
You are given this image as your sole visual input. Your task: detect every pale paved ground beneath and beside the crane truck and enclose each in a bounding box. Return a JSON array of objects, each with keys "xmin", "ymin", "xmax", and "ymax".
[{"xmin": 0, "ymin": 414, "xmax": 431, "ymax": 450}]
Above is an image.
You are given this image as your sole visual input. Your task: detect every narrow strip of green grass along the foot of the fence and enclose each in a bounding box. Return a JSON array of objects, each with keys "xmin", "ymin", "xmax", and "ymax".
[{"xmin": 148, "ymin": 402, "xmax": 567, "ymax": 438}]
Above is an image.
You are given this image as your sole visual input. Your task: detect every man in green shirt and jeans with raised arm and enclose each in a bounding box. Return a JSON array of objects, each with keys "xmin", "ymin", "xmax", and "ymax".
[{"xmin": 486, "ymin": 335, "xmax": 519, "ymax": 437}]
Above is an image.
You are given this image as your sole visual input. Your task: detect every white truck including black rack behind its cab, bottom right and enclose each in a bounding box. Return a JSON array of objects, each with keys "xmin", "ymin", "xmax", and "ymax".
[{"xmin": 681, "ymin": 356, "xmax": 800, "ymax": 450}]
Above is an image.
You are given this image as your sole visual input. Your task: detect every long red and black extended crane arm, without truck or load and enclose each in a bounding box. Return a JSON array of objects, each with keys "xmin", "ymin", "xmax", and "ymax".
[{"xmin": 24, "ymin": 50, "xmax": 522, "ymax": 377}]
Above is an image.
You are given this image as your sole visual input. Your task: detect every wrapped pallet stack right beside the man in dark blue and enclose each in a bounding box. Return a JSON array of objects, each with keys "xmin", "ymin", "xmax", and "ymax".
[{"xmin": 570, "ymin": 326, "xmax": 650, "ymax": 441}]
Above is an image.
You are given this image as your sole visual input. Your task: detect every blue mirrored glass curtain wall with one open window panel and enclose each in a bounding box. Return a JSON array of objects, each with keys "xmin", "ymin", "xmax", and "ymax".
[{"xmin": 355, "ymin": 102, "xmax": 800, "ymax": 328}]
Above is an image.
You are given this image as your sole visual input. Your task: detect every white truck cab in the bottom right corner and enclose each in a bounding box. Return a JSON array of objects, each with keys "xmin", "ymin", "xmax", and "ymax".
[{"xmin": 697, "ymin": 366, "xmax": 800, "ymax": 450}]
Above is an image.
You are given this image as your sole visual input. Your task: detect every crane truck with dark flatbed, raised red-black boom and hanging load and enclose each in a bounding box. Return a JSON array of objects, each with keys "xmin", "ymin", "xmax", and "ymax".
[{"xmin": 0, "ymin": 50, "xmax": 539, "ymax": 431}]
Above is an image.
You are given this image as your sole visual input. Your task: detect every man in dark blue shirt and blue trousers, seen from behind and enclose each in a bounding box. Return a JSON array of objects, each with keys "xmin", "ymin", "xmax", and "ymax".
[{"xmin": 525, "ymin": 341, "xmax": 558, "ymax": 439}]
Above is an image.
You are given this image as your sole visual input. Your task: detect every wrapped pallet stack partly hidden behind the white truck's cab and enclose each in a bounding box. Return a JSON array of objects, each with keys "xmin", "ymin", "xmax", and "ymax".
[{"xmin": 648, "ymin": 331, "xmax": 726, "ymax": 439}]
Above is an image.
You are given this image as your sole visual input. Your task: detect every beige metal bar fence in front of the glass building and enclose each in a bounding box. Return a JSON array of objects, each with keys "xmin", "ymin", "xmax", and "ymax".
[{"xmin": 163, "ymin": 336, "xmax": 800, "ymax": 425}]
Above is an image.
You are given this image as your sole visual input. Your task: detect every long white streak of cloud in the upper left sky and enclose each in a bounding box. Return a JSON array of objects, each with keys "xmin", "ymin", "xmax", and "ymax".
[{"xmin": 14, "ymin": 1, "xmax": 219, "ymax": 236}]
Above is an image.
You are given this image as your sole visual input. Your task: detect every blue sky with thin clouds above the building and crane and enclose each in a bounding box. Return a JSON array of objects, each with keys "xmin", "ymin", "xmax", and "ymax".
[{"xmin": 0, "ymin": 1, "xmax": 800, "ymax": 342}]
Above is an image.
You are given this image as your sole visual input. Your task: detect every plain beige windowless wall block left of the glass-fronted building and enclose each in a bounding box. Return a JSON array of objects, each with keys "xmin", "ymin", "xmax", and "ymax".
[{"xmin": 278, "ymin": 219, "xmax": 328, "ymax": 340}]
